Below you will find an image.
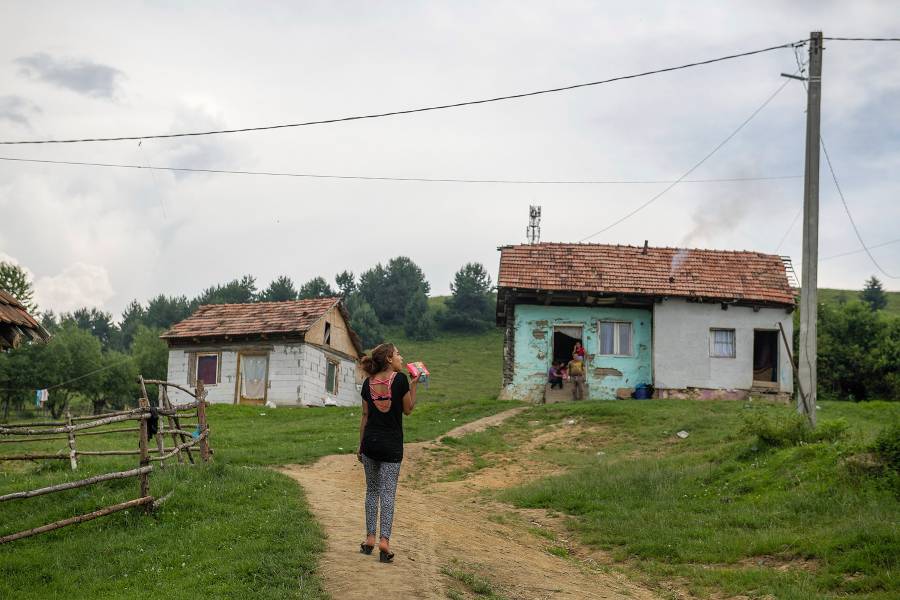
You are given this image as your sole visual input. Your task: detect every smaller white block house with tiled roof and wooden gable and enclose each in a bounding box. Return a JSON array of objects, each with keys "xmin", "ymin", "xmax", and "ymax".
[{"xmin": 160, "ymin": 298, "xmax": 363, "ymax": 406}]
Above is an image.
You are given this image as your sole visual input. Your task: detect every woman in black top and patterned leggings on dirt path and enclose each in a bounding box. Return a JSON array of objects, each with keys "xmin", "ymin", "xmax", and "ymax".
[{"xmin": 356, "ymin": 344, "xmax": 418, "ymax": 562}]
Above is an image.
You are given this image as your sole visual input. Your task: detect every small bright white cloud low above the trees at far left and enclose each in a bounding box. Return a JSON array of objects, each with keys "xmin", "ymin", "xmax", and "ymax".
[{"xmin": 34, "ymin": 262, "xmax": 115, "ymax": 312}]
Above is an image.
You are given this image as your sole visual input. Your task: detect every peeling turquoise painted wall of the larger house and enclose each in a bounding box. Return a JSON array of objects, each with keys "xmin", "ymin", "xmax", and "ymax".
[{"xmin": 506, "ymin": 304, "xmax": 653, "ymax": 400}]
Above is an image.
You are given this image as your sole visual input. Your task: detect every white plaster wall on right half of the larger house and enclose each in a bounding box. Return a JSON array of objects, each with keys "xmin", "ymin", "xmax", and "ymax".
[{"xmin": 653, "ymin": 299, "xmax": 793, "ymax": 393}]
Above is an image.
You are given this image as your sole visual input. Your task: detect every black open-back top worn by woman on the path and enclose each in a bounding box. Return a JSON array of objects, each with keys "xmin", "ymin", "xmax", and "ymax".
[{"xmin": 360, "ymin": 373, "xmax": 409, "ymax": 462}]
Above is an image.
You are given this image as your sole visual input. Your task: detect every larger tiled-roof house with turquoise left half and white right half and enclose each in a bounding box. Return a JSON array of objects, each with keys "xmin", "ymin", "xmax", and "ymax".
[{"xmin": 497, "ymin": 243, "xmax": 795, "ymax": 401}]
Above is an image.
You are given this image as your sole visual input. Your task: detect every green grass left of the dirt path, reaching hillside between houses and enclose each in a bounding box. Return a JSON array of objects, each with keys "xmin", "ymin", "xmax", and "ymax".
[{"xmin": 0, "ymin": 331, "xmax": 514, "ymax": 598}]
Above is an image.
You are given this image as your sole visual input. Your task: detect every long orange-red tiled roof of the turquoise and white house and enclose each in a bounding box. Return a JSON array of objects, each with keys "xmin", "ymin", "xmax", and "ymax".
[{"xmin": 497, "ymin": 243, "xmax": 795, "ymax": 306}]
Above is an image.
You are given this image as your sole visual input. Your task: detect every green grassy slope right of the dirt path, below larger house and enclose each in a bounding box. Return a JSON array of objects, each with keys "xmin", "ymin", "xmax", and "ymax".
[{"xmin": 442, "ymin": 401, "xmax": 900, "ymax": 600}]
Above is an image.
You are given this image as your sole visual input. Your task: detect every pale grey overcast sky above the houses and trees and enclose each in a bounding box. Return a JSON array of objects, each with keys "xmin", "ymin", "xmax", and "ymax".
[{"xmin": 0, "ymin": 0, "xmax": 900, "ymax": 317}]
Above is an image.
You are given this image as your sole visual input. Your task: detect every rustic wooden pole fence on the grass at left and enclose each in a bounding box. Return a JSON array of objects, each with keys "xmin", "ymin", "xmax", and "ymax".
[{"xmin": 0, "ymin": 378, "xmax": 212, "ymax": 544}]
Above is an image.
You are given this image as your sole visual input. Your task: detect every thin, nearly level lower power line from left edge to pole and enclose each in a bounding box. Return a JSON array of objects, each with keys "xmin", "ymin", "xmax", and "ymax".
[{"xmin": 0, "ymin": 156, "xmax": 803, "ymax": 185}]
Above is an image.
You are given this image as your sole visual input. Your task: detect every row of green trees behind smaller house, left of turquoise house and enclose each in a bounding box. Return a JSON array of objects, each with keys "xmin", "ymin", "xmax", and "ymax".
[{"xmin": 0, "ymin": 256, "xmax": 494, "ymax": 419}]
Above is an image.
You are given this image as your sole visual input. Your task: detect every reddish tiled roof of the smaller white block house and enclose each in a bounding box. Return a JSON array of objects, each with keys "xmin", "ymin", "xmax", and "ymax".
[{"xmin": 160, "ymin": 298, "xmax": 363, "ymax": 354}]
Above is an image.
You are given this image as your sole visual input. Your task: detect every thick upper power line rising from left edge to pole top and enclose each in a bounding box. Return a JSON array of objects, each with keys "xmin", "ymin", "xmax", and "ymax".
[{"xmin": 0, "ymin": 40, "xmax": 806, "ymax": 145}]
